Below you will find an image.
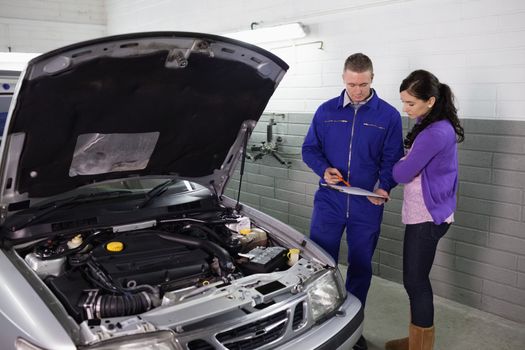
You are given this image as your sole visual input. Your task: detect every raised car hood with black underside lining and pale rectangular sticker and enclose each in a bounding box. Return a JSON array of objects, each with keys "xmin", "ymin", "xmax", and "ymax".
[{"xmin": 0, "ymin": 32, "xmax": 288, "ymax": 205}]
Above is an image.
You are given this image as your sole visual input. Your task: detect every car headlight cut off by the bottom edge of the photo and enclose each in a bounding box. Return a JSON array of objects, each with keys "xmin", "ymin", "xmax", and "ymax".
[{"xmin": 80, "ymin": 331, "xmax": 182, "ymax": 350}]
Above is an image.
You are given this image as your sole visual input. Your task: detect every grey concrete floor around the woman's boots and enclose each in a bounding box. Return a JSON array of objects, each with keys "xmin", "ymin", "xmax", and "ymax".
[{"xmin": 341, "ymin": 266, "xmax": 525, "ymax": 350}]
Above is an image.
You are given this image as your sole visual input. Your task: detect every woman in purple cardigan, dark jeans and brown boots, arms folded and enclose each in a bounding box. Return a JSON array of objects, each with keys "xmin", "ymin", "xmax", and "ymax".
[{"xmin": 385, "ymin": 70, "xmax": 464, "ymax": 350}]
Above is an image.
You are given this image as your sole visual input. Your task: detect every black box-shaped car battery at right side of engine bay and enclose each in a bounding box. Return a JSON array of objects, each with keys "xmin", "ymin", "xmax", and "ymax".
[{"xmin": 239, "ymin": 247, "xmax": 288, "ymax": 273}]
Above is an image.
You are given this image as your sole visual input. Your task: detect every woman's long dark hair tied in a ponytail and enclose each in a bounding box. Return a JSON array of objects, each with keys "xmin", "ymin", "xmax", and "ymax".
[{"xmin": 399, "ymin": 69, "xmax": 465, "ymax": 148}]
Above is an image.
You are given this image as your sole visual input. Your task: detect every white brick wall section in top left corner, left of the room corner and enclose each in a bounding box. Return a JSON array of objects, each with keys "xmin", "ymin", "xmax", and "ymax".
[{"xmin": 0, "ymin": 0, "xmax": 106, "ymax": 53}]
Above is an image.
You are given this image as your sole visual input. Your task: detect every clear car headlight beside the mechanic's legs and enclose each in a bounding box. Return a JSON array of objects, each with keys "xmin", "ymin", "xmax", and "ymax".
[{"xmin": 308, "ymin": 272, "xmax": 344, "ymax": 321}]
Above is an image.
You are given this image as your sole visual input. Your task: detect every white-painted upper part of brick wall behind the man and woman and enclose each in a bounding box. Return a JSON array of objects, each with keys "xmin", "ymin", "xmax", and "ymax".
[{"xmin": 105, "ymin": 0, "xmax": 525, "ymax": 120}]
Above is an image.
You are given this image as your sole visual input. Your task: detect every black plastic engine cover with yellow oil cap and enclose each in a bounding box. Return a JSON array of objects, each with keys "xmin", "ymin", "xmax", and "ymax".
[{"xmin": 92, "ymin": 231, "xmax": 210, "ymax": 287}]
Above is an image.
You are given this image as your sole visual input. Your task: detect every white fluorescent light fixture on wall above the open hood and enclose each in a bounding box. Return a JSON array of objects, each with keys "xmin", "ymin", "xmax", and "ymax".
[{"xmin": 223, "ymin": 23, "xmax": 306, "ymax": 44}]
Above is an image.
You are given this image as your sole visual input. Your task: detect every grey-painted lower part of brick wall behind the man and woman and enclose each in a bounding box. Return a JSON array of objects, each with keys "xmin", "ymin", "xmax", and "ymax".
[{"xmin": 226, "ymin": 113, "xmax": 525, "ymax": 323}]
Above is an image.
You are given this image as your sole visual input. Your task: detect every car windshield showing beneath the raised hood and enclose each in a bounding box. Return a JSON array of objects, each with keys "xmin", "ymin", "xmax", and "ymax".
[{"xmin": 0, "ymin": 176, "xmax": 216, "ymax": 241}]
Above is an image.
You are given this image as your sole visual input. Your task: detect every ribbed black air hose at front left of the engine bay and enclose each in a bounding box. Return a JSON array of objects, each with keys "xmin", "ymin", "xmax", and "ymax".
[{"xmin": 95, "ymin": 292, "xmax": 152, "ymax": 318}]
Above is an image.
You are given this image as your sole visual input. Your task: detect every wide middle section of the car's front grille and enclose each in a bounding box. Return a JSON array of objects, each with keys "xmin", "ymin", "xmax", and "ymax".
[{"xmin": 217, "ymin": 311, "xmax": 288, "ymax": 350}]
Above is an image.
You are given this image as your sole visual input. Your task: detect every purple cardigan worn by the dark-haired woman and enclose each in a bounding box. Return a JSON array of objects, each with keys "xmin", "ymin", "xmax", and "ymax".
[{"xmin": 393, "ymin": 120, "xmax": 458, "ymax": 225}]
